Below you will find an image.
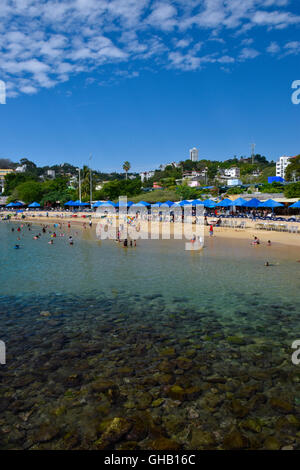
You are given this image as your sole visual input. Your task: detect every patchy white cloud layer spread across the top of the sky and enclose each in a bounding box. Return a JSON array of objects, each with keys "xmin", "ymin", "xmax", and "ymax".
[{"xmin": 0, "ymin": 0, "xmax": 300, "ymax": 96}]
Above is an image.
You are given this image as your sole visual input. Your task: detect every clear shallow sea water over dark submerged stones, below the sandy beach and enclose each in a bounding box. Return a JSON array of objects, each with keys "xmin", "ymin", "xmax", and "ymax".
[{"xmin": 0, "ymin": 224, "xmax": 300, "ymax": 448}]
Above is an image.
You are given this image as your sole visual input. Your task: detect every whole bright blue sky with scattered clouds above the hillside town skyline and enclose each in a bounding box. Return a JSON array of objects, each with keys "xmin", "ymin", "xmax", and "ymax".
[{"xmin": 0, "ymin": 0, "xmax": 300, "ymax": 171}]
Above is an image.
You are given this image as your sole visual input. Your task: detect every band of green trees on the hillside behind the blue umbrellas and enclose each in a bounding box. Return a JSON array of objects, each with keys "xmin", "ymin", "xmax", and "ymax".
[{"xmin": 0, "ymin": 155, "xmax": 300, "ymax": 205}]
